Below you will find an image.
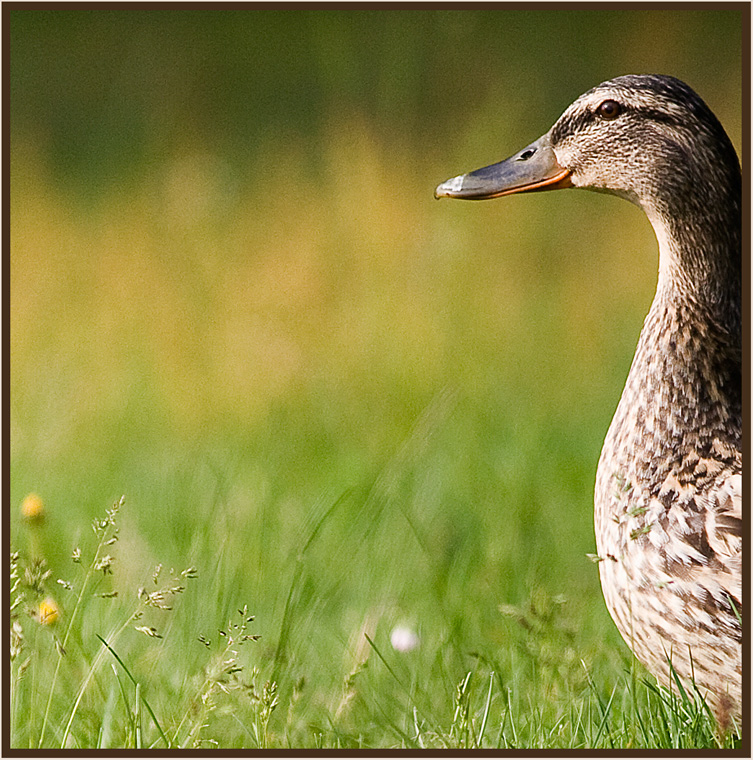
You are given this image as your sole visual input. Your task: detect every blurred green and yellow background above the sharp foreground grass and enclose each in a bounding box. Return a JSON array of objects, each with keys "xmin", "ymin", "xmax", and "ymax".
[{"xmin": 4, "ymin": 5, "xmax": 742, "ymax": 744}]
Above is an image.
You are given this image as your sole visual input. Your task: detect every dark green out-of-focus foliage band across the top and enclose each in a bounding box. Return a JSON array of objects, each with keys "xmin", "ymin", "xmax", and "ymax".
[{"xmin": 8, "ymin": 7, "xmax": 741, "ymax": 185}]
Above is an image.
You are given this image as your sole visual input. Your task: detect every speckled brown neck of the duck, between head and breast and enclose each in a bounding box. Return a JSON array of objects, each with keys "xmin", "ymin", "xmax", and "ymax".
[{"xmin": 626, "ymin": 196, "xmax": 742, "ymax": 456}]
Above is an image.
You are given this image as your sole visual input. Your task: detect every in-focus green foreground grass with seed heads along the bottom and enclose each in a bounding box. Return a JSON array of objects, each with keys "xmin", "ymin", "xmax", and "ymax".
[{"xmin": 10, "ymin": 499, "xmax": 735, "ymax": 749}]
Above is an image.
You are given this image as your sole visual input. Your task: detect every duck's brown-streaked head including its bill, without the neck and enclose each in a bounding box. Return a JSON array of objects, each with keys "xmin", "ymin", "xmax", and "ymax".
[{"xmin": 435, "ymin": 75, "xmax": 740, "ymax": 221}]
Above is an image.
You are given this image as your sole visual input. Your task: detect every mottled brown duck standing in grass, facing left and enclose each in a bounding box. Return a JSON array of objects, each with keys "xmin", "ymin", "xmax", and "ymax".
[{"xmin": 435, "ymin": 74, "xmax": 743, "ymax": 733}]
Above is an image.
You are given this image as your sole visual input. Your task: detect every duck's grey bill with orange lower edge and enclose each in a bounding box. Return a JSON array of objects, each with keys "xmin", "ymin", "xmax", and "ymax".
[{"xmin": 434, "ymin": 134, "xmax": 572, "ymax": 200}]
